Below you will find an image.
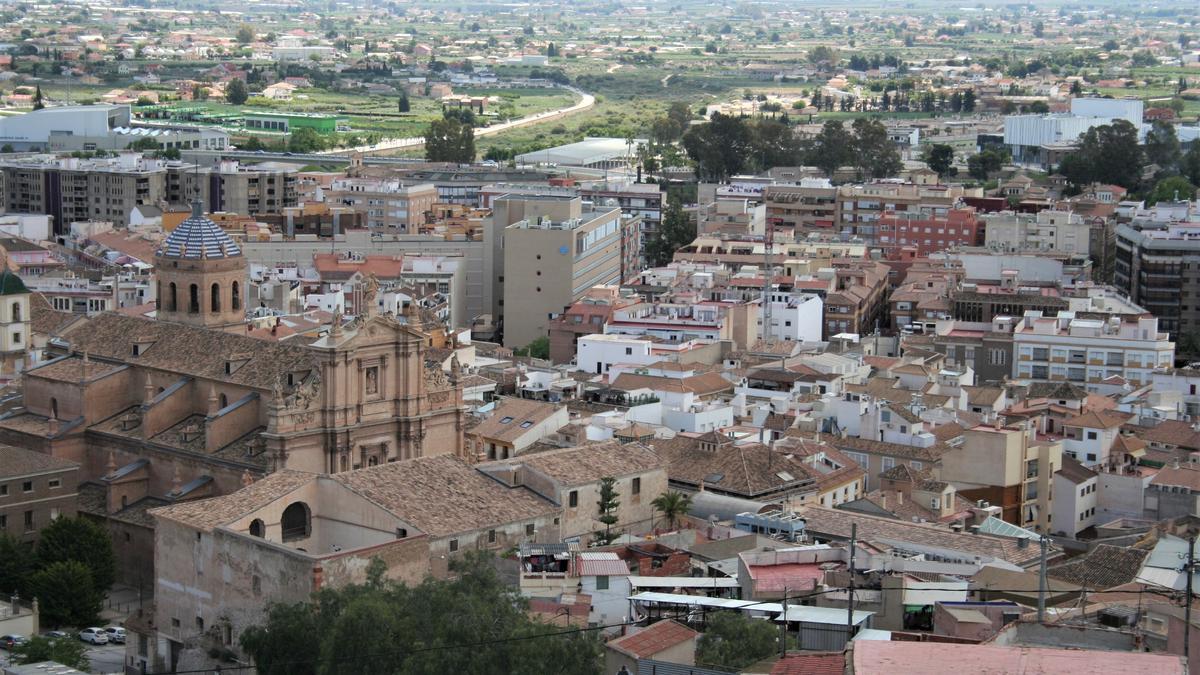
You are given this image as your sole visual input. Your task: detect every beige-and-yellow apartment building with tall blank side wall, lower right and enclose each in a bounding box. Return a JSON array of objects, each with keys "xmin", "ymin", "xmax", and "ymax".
[{"xmin": 941, "ymin": 423, "xmax": 1062, "ymax": 532}]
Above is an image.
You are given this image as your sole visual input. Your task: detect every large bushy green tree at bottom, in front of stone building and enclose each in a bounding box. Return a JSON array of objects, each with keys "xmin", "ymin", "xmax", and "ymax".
[{"xmin": 241, "ymin": 554, "xmax": 602, "ymax": 675}]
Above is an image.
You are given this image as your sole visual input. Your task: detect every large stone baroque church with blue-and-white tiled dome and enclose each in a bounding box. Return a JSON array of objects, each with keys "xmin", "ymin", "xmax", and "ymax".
[{"xmin": 0, "ymin": 207, "xmax": 466, "ymax": 578}]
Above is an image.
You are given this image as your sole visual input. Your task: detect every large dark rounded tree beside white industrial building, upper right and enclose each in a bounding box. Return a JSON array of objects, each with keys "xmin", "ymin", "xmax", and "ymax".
[{"xmin": 1058, "ymin": 120, "xmax": 1146, "ymax": 190}]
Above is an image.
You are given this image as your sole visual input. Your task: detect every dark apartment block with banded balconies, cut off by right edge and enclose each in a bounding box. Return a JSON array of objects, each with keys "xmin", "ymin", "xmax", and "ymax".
[{"xmin": 1112, "ymin": 220, "xmax": 1200, "ymax": 336}]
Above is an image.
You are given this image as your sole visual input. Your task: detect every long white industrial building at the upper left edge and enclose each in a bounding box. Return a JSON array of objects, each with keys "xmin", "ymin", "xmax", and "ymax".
[{"xmin": 0, "ymin": 104, "xmax": 229, "ymax": 153}]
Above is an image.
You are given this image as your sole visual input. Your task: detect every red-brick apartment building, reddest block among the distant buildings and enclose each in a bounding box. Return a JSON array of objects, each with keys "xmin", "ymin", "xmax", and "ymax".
[{"xmin": 876, "ymin": 207, "xmax": 984, "ymax": 258}]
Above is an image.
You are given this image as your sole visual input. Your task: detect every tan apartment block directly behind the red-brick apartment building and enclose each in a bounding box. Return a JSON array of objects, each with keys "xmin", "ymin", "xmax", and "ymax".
[{"xmin": 836, "ymin": 180, "xmax": 967, "ymax": 246}]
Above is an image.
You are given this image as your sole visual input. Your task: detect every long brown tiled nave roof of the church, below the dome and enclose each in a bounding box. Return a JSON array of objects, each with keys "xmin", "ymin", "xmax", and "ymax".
[{"xmin": 63, "ymin": 312, "xmax": 317, "ymax": 389}]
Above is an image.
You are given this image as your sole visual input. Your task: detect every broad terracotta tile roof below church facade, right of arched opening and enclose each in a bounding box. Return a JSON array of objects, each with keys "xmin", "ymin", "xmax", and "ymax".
[{"xmin": 331, "ymin": 455, "xmax": 558, "ymax": 537}]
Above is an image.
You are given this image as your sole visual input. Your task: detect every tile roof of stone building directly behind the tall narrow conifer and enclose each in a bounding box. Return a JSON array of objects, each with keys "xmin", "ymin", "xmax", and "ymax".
[{"xmin": 506, "ymin": 442, "xmax": 667, "ymax": 485}]
